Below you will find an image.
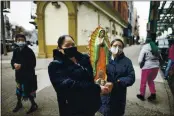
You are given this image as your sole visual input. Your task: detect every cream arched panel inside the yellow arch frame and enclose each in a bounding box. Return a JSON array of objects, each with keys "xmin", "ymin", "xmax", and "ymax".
[{"xmin": 44, "ymin": 2, "xmax": 68, "ymax": 57}]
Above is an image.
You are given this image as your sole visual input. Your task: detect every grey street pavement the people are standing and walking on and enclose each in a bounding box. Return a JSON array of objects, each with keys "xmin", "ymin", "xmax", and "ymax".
[{"xmin": 1, "ymin": 45, "xmax": 174, "ymax": 116}]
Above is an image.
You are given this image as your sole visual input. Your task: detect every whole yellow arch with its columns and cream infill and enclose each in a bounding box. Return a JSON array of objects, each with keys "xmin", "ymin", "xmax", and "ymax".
[{"xmin": 37, "ymin": 1, "xmax": 77, "ymax": 58}]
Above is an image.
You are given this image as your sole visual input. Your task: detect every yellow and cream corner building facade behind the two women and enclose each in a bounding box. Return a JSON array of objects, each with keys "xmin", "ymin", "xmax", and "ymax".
[{"xmin": 35, "ymin": 1, "xmax": 127, "ymax": 58}]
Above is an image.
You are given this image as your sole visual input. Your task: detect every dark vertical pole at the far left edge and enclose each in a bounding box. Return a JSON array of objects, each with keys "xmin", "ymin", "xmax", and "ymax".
[{"xmin": 1, "ymin": 1, "xmax": 7, "ymax": 56}]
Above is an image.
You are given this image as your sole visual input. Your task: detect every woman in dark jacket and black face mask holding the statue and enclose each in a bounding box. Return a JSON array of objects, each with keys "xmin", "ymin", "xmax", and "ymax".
[{"xmin": 48, "ymin": 35, "xmax": 108, "ymax": 116}]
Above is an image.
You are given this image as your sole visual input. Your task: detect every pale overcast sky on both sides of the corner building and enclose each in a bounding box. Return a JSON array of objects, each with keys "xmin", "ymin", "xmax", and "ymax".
[{"xmin": 8, "ymin": 1, "xmax": 150, "ymax": 37}]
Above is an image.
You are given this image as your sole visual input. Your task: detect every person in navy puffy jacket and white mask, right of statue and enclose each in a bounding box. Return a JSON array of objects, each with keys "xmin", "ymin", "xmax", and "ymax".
[{"xmin": 99, "ymin": 39, "xmax": 135, "ymax": 116}]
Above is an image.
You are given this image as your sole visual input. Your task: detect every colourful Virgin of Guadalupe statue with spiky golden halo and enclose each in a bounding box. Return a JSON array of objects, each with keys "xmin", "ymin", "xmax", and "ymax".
[{"xmin": 89, "ymin": 26, "xmax": 110, "ymax": 83}]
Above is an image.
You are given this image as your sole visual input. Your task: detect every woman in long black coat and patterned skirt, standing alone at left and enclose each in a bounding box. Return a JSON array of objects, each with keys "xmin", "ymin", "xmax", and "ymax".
[{"xmin": 11, "ymin": 34, "xmax": 38, "ymax": 114}]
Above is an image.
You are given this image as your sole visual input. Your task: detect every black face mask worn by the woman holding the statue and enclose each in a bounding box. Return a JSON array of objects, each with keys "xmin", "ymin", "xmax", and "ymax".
[{"xmin": 63, "ymin": 47, "xmax": 77, "ymax": 58}]
